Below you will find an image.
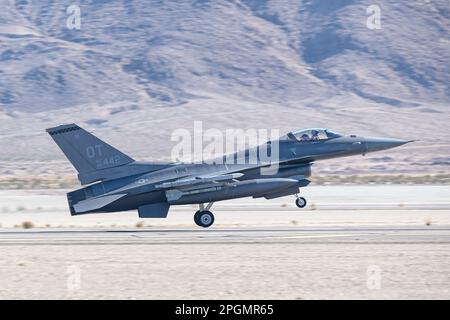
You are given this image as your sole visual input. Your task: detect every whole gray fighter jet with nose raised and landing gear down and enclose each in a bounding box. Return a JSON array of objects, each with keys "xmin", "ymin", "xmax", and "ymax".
[{"xmin": 46, "ymin": 124, "xmax": 410, "ymax": 228}]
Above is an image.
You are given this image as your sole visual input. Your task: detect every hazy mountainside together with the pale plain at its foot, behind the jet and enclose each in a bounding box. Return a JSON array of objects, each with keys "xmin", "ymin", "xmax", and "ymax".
[{"xmin": 0, "ymin": 0, "xmax": 450, "ymax": 178}]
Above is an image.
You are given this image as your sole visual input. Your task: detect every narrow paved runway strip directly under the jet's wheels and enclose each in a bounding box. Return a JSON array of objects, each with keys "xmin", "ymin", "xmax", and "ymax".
[{"xmin": 0, "ymin": 226, "xmax": 450, "ymax": 247}]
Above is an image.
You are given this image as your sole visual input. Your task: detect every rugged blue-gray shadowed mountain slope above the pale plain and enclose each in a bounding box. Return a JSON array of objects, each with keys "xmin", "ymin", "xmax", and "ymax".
[{"xmin": 0, "ymin": 0, "xmax": 450, "ymax": 112}]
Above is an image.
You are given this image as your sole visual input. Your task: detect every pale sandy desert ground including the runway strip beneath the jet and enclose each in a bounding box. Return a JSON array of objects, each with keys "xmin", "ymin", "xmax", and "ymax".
[{"xmin": 0, "ymin": 185, "xmax": 450, "ymax": 299}]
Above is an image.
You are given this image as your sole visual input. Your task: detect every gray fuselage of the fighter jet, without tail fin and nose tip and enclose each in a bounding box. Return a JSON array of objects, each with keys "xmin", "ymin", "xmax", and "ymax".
[{"xmin": 68, "ymin": 136, "xmax": 380, "ymax": 212}]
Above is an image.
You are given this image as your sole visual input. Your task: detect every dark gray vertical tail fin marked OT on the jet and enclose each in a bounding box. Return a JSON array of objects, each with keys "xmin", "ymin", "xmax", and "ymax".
[{"xmin": 46, "ymin": 124, "xmax": 134, "ymax": 173}]
